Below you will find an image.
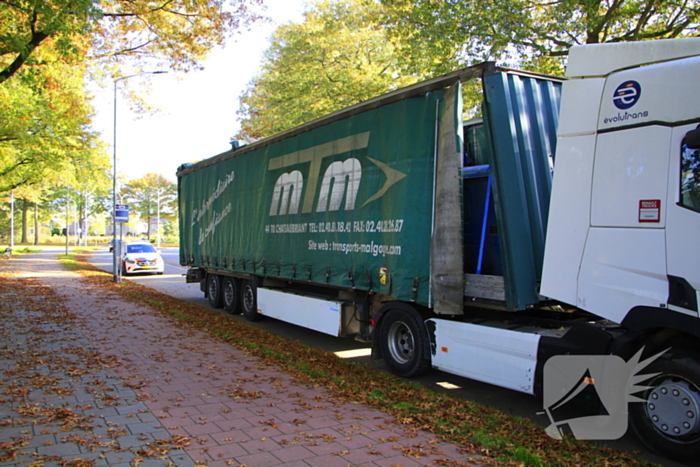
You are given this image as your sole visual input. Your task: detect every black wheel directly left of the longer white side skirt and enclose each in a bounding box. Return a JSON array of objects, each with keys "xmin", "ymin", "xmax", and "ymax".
[{"xmin": 379, "ymin": 309, "xmax": 430, "ymax": 378}]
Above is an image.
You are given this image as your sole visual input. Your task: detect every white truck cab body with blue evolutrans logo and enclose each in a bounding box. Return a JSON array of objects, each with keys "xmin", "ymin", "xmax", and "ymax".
[{"xmin": 541, "ymin": 39, "xmax": 700, "ymax": 323}]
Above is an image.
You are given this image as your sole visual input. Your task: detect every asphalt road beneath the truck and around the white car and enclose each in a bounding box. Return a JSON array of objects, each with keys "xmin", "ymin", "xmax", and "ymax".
[{"xmin": 90, "ymin": 247, "xmax": 683, "ymax": 467}]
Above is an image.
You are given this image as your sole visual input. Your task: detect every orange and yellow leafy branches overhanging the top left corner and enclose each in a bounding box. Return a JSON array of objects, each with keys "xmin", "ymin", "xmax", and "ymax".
[{"xmin": 0, "ymin": 0, "xmax": 260, "ymax": 83}]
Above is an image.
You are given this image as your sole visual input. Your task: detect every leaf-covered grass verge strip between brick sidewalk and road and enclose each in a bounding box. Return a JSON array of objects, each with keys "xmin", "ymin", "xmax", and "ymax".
[{"xmin": 61, "ymin": 252, "xmax": 656, "ymax": 467}]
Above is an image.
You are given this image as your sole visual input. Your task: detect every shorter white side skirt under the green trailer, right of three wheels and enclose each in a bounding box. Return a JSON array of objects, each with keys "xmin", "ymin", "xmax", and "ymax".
[{"xmin": 258, "ymin": 288, "xmax": 343, "ymax": 337}]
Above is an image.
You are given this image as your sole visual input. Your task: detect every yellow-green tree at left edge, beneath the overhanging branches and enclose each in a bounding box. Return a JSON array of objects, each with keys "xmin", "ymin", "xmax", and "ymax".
[{"xmin": 0, "ymin": 59, "xmax": 106, "ymax": 192}]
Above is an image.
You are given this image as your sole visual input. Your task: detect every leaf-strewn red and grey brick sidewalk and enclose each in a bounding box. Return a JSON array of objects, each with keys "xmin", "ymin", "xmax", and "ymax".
[{"xmin": 0, "ymin": 253, "xmax": 484, "ymax": 467}]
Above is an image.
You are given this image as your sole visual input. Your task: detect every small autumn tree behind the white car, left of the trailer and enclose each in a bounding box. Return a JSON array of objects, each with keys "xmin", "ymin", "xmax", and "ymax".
[{"xmin": 124, "ymin": 174, "xmax": 177, "ymax": 240}]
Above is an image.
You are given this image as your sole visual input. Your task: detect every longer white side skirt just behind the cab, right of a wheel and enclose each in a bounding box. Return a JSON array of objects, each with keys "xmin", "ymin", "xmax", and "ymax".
[{"xmin": 428, "ymin": 319, "xmax": 540, "ymax": 394}]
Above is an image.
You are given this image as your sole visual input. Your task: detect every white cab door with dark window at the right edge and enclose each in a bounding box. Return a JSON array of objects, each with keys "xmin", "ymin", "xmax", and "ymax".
[{"xmin": 666, "ymin": 123, "xmax": 700, "ymax": 316}]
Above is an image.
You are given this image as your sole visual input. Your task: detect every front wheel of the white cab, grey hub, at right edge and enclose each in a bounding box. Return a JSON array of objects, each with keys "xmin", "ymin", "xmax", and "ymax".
[{"xmin": 629, "ymin": 351, "xmax": 700, "ymax": 462}]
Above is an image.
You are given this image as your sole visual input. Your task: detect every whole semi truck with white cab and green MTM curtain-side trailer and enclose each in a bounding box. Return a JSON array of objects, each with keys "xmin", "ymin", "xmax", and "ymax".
[{"xmin": 177, "ymin": 38, "xmax": 700, "ymax": 461}]
